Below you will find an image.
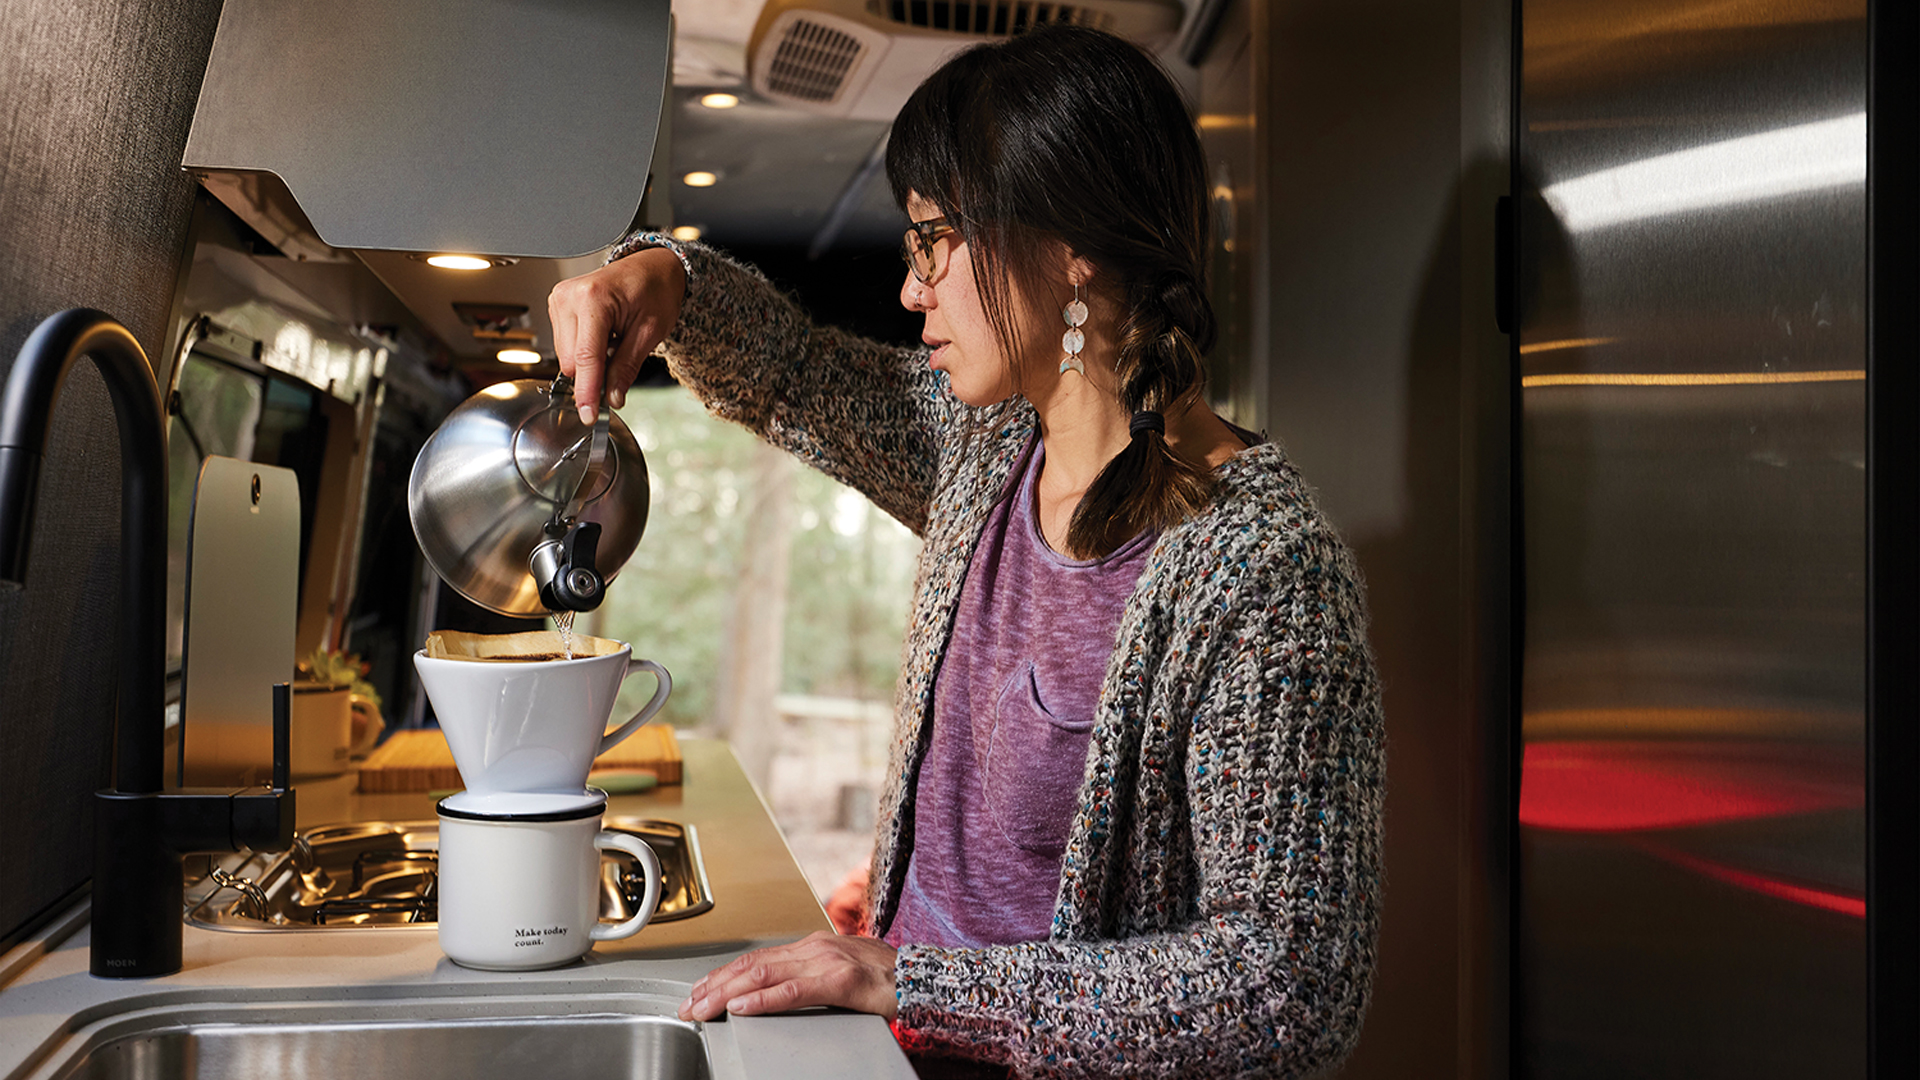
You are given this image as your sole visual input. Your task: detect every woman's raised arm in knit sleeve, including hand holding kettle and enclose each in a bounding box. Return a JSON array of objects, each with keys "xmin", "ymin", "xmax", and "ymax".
[{"xmin": 549, "ymin": 244, "xmax": 960, "ymax": 532}]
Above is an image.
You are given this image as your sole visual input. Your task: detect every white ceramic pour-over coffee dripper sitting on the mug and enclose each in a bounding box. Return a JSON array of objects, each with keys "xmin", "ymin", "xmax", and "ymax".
[{"xmin": 413, "ymin": 646, "xmax": 674, "ymax": 796}]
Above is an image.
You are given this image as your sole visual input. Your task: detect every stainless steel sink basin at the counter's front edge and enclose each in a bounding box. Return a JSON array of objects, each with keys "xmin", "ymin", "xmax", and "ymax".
[{"xmin": 27, "ymin": 994, "xmax": 737, "ymax": 1080}]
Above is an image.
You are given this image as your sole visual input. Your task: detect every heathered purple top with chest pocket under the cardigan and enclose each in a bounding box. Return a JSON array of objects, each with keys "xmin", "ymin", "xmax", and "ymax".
[{"xmin": 887, "ymin": 440, "xmax": 1154, "ymax": 947}]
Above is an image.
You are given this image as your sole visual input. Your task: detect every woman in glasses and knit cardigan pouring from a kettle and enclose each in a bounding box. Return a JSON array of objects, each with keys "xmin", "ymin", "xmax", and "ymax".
[{"xmin": 551, "ymin": 29, "xmax": 1382, "ymax": 1076}]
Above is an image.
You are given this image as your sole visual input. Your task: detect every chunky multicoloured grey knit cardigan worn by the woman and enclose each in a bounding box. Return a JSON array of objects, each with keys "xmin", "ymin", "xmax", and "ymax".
[{"xmin": 662, "ymin": 244, "xmax": 1384, "ymax": 1076}]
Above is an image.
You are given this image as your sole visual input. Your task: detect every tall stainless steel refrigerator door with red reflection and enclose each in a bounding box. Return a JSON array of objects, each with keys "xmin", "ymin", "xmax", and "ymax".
[{"xmin": 1517, "ymin": 0, "xmax": 1866, "ymax": 1078}]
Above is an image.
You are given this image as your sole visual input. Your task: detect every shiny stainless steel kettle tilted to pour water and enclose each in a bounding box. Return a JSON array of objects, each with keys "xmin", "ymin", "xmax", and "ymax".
[{"xmin": 407, "ymin": 377, "xmax": 649, "ymax": 617}]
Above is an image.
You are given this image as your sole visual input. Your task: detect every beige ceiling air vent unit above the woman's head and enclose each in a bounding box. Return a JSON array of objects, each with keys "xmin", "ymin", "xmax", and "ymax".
[{"xmin": 747, "ymin": 0, "xmax": 1185, "ymax": 119}]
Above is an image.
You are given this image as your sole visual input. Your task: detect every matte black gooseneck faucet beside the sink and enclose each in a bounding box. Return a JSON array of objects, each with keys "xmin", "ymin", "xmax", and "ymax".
[{"xmin": 0, "ymin": 307, "xmax": 294, "ymax": 978}]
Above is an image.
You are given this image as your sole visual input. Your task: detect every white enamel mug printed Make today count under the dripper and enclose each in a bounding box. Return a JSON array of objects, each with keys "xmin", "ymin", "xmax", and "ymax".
[{"xmin": 438, "ymin": 788, "xmax": 660, "ymax": 970}]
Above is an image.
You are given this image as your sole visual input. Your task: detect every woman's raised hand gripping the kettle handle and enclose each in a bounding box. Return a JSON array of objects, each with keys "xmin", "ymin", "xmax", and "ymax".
[{"xmin": 547, "ymin": 248, "xmax": 687, "ymax": 423}]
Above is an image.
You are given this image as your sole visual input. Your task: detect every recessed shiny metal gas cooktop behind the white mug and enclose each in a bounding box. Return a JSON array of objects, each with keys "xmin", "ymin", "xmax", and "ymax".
[{"xmin": 186, "ymin": 817, "xmax": 712, "ymax": 932}]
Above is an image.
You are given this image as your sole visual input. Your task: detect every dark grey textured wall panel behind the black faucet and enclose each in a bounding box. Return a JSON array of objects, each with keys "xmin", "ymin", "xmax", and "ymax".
[{"xmin": 0, "ymin": 0, "xmax": 221, "ymax": 942}]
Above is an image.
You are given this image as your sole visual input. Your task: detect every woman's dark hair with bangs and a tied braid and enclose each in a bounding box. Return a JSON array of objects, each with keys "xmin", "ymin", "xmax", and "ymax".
[{"xmin": 887, "ymin": 27, "xmax": 1213, "ymax": 557}]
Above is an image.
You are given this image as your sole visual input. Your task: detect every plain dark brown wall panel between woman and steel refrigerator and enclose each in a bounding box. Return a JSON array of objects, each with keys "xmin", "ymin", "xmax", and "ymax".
[{"xmin": 1235, "ymin": 0, "xmax": 1511, "ymax": 1080}]
